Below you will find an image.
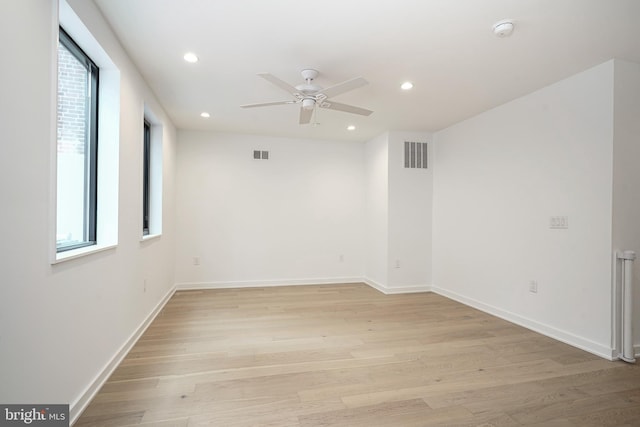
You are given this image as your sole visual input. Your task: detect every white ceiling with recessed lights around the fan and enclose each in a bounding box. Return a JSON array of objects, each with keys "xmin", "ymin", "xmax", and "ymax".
[{"xmin": 95, "ymin": 0, "xmax": 640, "ymax": 141}]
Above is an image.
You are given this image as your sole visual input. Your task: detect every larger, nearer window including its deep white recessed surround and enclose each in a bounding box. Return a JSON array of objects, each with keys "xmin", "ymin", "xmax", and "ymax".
[{"xmin": 50, "ymin": 0, "xmax": 120, "ymax": 264}]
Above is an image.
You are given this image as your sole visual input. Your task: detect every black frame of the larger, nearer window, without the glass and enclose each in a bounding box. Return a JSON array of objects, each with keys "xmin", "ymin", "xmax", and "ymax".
[{"xmin": 56, "ymin": 25, "xmax": 100, "ymax": 253}]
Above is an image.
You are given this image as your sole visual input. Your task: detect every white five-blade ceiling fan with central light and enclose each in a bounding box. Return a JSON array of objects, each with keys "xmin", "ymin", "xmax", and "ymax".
[{"xmin": 241, "ymin": 69, "xmax": 373, "ymax": 125}]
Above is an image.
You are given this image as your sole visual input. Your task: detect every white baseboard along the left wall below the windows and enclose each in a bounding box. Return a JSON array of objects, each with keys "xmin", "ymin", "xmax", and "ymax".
[{"xmin": 69, "ymin": 286, "xmax": 176, "ymax": 425}]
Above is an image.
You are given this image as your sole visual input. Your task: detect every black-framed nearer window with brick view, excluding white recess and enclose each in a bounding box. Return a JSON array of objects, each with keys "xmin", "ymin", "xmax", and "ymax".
[{"xmin": 56, "ymin": 28, "xmax": 99, "ymax": 252}]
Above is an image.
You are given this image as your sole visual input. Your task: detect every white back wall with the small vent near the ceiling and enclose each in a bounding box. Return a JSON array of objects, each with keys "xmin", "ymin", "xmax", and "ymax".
[{"xmin": 176, "ymin": 131, "xmax": 364, "ymax": 287}]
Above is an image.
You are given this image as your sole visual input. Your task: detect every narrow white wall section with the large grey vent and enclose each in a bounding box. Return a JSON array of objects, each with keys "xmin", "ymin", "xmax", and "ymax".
[{"xmin": 387, "ymin": 131, "xmax": 433, "ymax": 290}]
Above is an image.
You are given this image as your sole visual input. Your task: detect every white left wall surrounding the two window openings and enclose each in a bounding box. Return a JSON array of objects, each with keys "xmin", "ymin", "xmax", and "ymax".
[{"xmin": 0, "ymin": 0, "xmax": 176, "ymax": 422}]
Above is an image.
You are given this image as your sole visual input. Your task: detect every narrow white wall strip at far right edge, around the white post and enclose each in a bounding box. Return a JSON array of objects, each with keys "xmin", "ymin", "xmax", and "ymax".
[{"xmin": 613, "ymin": 60, "xmax": 640, "ymax": 352}]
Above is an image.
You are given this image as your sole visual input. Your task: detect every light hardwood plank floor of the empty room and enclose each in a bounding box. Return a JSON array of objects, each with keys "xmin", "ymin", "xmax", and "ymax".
[{"xmin": 76, "ymin": 284, "xmax": 640, "ymax": 427}]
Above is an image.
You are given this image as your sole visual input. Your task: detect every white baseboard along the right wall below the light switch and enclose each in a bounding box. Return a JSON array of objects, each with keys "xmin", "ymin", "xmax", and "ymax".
[{"xmin": 431, "ymin": 286, "xmax": 617, "ymax": 360}]
